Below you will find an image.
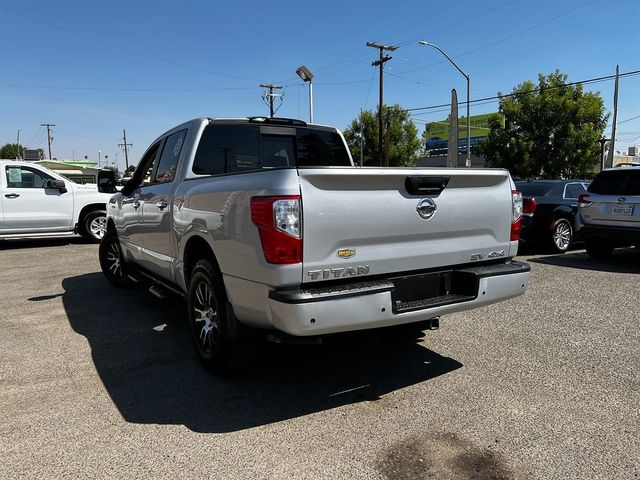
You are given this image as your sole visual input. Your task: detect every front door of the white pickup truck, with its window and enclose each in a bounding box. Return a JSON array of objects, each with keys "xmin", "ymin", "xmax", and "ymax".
[{"xmin": 2, "ymin": 164, "xmax": 73, "ymax": 233}]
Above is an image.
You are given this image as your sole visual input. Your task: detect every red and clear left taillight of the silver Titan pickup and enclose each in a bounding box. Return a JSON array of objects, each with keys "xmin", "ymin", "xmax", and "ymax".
[{"xmin": 251, "ymin": 195, "xmax": 302, "ymax": 265}]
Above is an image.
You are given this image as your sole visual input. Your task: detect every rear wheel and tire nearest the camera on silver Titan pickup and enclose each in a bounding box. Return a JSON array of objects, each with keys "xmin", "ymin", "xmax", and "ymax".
[{"xmin": 187, "ymin": 259, "xmax": 255, "ymax": 375}]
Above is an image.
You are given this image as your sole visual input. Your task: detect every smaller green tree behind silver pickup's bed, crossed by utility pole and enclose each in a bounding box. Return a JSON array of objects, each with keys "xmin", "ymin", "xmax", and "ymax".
[{"xmin": 344, "ymin": 105, "xmax": 423, "ymax": 167}]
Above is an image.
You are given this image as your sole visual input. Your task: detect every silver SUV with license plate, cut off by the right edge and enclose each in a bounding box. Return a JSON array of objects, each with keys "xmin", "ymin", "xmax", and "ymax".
[{"xmin": 578, "ymin": 166, "xmax": 640, "ymax": 259}]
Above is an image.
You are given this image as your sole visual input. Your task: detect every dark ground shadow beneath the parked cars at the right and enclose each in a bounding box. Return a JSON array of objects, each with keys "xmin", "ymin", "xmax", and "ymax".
[{"xmin": 527, "ymin": 248, "xmax": 640, "ymax": 273}]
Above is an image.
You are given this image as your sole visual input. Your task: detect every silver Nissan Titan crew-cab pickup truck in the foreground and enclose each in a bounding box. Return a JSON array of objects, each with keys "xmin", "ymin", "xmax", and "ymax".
[{"xmin": 100, "ymin": 117, "xmax": 529, "ymax": 372}]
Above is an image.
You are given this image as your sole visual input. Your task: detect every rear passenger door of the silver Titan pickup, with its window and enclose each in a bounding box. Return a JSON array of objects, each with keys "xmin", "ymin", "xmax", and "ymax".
[{"xmin": 139, "ymin": 129, "xmax": 187, "ymax": 280}]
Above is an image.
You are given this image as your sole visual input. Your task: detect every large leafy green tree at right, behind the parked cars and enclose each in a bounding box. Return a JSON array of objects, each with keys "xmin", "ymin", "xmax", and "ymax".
[{"xmin": 477, "ymin": 70, "xmax": 609, "ymax": 178}]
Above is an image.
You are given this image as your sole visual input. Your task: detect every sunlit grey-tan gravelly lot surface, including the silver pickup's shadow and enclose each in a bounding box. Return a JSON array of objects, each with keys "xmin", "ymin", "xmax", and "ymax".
[{"xmin": 0, "ymin": 240, "xmax": 640, "ymax": 479}]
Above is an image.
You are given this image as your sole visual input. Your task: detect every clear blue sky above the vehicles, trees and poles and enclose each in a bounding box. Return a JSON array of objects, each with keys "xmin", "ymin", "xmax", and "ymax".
[{"xmin": 0, "ymin": 0, "xmax": 640, "ymax": 171}]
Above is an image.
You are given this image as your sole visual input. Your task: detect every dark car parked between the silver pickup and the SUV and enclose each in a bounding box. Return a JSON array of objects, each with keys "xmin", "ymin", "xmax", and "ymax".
[{"xmin": 516, "ymin": 180, "xmax": 589, "ymax": 253}]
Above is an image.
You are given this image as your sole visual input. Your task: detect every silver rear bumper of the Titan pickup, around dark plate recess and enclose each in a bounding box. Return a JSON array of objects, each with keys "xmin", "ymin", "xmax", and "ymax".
[{"xmin": 268, "ymin": 262, "xmax": 530, "ymax": 336}]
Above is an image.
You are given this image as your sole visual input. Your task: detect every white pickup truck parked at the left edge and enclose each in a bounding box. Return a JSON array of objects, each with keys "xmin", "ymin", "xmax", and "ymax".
[{"xmin": 0, "ymin": 160, "xmax": 111, "ymax": 242}]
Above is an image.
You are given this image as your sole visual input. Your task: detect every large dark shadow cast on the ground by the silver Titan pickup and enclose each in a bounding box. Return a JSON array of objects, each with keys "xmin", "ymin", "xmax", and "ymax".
[{"xmin": 62, "ymin": 273, "xmax": 462, "ymax": 432}]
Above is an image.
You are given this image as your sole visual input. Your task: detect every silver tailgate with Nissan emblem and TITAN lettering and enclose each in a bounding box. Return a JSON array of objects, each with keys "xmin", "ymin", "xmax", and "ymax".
[{"xmin": 299, "ymin": 168, "xmax": 512, "ymax": 283}]
